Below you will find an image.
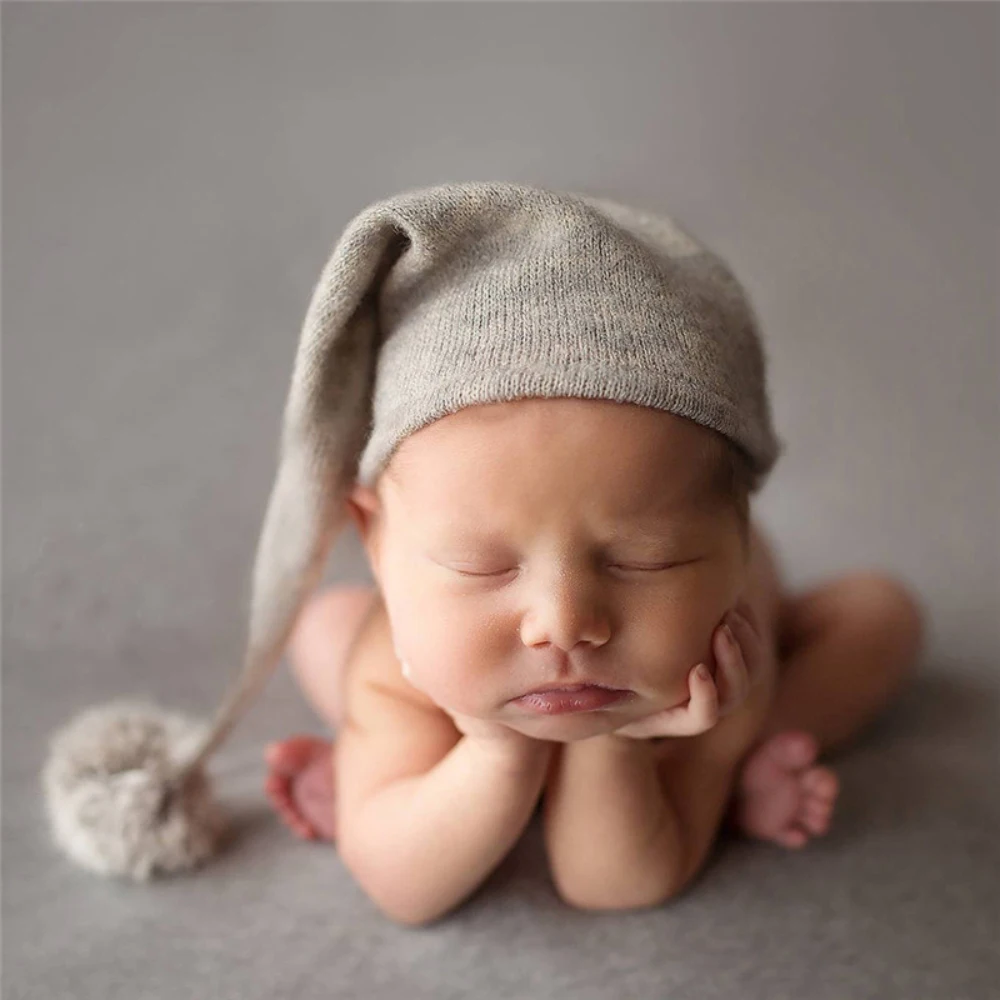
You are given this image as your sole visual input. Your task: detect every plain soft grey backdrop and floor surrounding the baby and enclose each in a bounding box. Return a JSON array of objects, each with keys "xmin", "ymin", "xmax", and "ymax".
[{"xmin": 2, "ymin": 3, "xmax": 1000, "ymax": 1000}]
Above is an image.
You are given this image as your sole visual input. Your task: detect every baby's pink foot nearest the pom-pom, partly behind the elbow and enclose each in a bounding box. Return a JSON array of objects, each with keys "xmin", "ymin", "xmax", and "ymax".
[{"xmin": 264, "ymin": 736, "xmax": 334, "ymax": 840}]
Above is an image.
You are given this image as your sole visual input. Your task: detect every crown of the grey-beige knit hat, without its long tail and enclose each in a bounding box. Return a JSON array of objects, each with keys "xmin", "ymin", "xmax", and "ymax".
[{"xmin": 356, "ymin": 184, "xmax": 781, "ymax": 486}]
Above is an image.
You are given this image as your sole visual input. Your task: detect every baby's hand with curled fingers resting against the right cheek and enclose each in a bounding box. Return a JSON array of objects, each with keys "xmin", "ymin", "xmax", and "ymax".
[{"xmin": 615, "ymin": 602, "xmax": 763, "ymax": 739}]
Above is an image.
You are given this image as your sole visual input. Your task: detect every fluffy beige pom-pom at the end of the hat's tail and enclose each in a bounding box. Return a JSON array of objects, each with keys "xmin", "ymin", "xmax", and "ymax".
[{"xmin": 42, "ymin": 699, "xmax": 224, "ymax": 880}]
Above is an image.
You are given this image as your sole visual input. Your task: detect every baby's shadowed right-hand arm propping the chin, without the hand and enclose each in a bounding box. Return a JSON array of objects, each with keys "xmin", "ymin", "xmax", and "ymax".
[{"xmin": 545, "ymin": 608, "xmax": 772, "ymax": 909}]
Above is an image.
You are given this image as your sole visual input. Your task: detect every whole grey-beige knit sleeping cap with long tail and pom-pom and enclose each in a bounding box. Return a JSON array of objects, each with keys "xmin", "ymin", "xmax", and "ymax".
[{"xmin": 45, "ymin": 183, "xmax": 784, "ymax": 877}]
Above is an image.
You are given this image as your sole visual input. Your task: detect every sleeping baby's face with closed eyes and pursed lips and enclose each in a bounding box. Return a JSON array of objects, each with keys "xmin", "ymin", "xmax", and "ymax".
[{"xmin": 352, "ymin": 399, "xmax": 745, "ymax": 741}]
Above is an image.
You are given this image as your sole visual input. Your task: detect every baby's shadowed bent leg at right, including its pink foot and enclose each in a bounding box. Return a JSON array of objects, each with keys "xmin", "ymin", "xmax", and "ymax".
[{"xmin": 734, "ymin": 573, "xmax": 924, "ymax": 847}]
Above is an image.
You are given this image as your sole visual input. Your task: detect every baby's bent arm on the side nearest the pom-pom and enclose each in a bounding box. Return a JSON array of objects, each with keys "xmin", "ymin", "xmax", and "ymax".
[{"xmin": 336, "ymin": 620, "xmax": 551, "ymax": 924}]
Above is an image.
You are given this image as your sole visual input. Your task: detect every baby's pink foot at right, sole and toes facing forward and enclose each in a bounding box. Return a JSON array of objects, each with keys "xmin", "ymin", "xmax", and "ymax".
[{"xmin": 733, "ymin": 732, "xmax": 840, "ymax": 847}]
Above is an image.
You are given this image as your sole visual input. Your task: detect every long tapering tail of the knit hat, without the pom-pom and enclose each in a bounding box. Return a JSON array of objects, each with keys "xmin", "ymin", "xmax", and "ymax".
[{"xmin": 176, "ymin": 214, "xmax": 407, "ymax": 783}]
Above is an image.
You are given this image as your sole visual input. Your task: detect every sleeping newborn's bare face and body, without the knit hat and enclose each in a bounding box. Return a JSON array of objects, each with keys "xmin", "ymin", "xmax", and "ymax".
[{"xmin": 267, "ymin": 398, "xmax": 921, "ymax": 924}]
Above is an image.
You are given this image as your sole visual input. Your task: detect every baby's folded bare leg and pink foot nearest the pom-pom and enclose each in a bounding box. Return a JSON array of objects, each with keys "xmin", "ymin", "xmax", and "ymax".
[{"xmin": 264, "ymin": 586, "xmax": 376, "ymax": 840}]
